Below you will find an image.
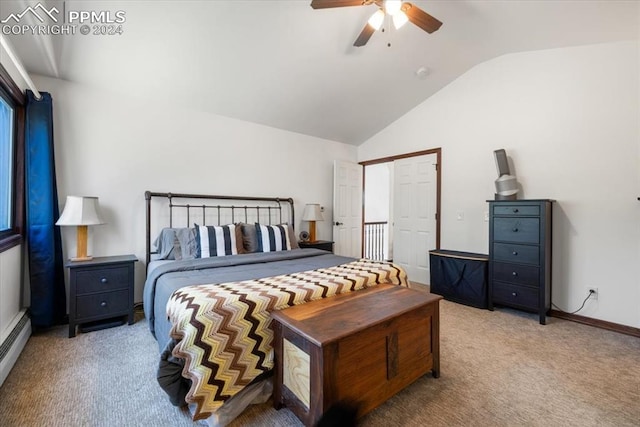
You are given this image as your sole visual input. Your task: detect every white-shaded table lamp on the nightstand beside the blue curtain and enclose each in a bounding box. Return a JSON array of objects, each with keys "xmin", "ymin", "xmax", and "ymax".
[{"xmin": 56, "ymin": 196, "xmax": 105, "ymax": 261}]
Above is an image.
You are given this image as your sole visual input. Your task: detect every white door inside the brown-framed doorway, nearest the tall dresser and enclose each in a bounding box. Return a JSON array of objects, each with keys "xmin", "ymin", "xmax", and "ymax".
[{"xmin": 393, "ymin": 154, "xmax": 437, "ymax": 284}]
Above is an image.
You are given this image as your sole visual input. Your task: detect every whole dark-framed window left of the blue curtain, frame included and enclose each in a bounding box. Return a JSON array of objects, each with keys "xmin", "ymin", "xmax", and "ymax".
[{"xmin": 0, "ymin": 64, "xmax": 25, "ymax": 252}]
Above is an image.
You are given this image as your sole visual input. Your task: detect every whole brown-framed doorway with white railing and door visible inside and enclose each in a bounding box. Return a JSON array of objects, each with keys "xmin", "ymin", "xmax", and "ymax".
[{"xmin": 360, "ymin": 148, "xmax": 442, "ymax": 284}]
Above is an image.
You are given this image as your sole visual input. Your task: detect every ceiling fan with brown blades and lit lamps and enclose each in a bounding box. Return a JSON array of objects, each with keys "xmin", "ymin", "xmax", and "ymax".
[{"xmin": 311, "ymin": 0, "xmax": 442, "ymax": 47}]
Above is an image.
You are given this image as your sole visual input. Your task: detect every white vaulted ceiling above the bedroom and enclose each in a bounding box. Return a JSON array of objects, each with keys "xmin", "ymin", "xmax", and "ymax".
[{"xmin": 0, "ymin": 0, "xmax": 640, "ymax": 145}]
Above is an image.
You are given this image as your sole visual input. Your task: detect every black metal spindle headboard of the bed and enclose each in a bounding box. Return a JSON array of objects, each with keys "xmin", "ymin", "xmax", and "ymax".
[{"xmin": 144, "ymin": 191, "xmax": 295, "ymax": 266}]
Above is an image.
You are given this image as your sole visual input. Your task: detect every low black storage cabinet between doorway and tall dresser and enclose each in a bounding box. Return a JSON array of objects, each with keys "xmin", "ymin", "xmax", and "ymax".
[{"xmin": 429, "ymin": 249, "xmax": 489, "ymax": 308}]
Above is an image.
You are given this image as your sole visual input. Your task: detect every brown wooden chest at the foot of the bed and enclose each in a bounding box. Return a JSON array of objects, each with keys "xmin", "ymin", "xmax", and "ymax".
[{"xmin": 272, "ymin": 285, "xmax": 441, "ymax": 426}]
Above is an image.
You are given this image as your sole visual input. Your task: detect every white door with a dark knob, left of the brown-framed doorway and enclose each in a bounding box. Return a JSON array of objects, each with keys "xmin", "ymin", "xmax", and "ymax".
[{"xmin": 333, "ymin": 160, "xmax": 362, "ymax": 258}]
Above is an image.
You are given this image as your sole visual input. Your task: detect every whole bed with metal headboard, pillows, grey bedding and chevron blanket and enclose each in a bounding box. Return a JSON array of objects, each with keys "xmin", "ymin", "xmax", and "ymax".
[{"xmin": 144, "ymin": 191, "xmax": 408, "ymax": 425}]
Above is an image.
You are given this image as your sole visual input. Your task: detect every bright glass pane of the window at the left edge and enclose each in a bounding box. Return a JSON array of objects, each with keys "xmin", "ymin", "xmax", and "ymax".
[{"xmin": 0, "ymin": 97, "xmax": 15, "ymax": 233}]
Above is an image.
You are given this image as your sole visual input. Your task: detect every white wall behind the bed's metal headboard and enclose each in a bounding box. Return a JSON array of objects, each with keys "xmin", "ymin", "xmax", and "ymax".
[{"xmin": 34, "ymin": 76, "xmax": 356, "ymax": 301}]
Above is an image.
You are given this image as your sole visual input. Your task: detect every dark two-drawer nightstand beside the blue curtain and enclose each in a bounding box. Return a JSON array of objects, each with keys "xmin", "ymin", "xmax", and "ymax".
[{"xmin": 65, "ymin": 255, "xmax": 138, "ymax": 338}]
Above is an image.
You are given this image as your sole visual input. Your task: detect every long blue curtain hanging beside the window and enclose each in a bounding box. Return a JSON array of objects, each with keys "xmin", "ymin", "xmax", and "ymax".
[{"xmin": 25, "ymin": 90, "xmax": 67, "ymax": 328}]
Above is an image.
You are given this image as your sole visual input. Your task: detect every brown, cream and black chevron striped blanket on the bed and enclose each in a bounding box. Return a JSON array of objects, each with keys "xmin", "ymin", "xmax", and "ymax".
[{"xmin": 167, "ymin": 260, "xmax": 408, "ymax": 420}]
